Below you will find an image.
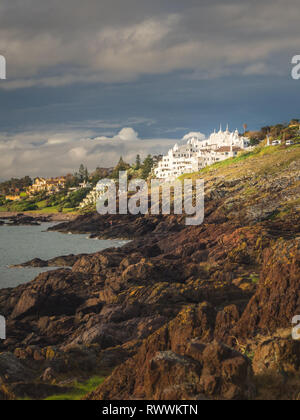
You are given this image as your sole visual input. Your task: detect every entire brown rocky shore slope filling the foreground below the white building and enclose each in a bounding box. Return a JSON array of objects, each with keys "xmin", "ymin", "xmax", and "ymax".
[{"xmin": 0, "ymin": 146, "xmax": 300, "ymax": 399}]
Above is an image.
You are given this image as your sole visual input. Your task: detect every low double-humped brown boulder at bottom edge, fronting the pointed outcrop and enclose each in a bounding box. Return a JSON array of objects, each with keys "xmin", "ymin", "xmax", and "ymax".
[{"xmin": 145, "ymin": 342, "xmax": 254, "ymax": 400}]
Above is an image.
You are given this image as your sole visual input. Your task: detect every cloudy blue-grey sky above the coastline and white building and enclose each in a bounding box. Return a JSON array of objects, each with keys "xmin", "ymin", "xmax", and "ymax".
[{"xmin": 0, "ymin": 0, "xmax": 300, "ymax": 179}]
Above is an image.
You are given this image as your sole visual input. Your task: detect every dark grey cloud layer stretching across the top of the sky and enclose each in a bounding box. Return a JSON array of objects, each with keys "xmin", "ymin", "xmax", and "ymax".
[{"xmin": 0, "ymin": 0, "xmax": 300, "ymax": 88}]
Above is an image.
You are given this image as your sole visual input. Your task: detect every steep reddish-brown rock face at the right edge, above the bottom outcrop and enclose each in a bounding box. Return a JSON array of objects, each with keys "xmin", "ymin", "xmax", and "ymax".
[{"xmin": 233, "ymin": 240, "xmax": 300, "ymax": 337}]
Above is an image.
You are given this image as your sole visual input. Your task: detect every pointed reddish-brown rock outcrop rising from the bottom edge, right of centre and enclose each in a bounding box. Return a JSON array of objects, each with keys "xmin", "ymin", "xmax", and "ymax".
[{"xmin": 88, "ymin": 304, "xmax": 255, "ymax": 400}]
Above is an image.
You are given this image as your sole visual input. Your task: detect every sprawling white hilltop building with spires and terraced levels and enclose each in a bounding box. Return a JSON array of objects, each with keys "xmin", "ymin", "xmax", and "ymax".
[{"xmin": 154, "ymin": 126, "xmax": 250, "ymax": 180}]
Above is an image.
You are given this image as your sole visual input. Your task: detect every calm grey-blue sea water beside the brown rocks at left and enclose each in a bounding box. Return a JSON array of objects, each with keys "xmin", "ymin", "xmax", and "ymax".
[{"xmin": 0, "ymin": 223, "xmax": 126, "ymax": 289}]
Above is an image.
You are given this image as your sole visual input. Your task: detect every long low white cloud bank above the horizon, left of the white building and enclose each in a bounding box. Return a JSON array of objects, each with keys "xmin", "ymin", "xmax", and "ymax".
[{"xmin": 0, "ymin": 127, "xmax": 176, "ymax": 179}]
